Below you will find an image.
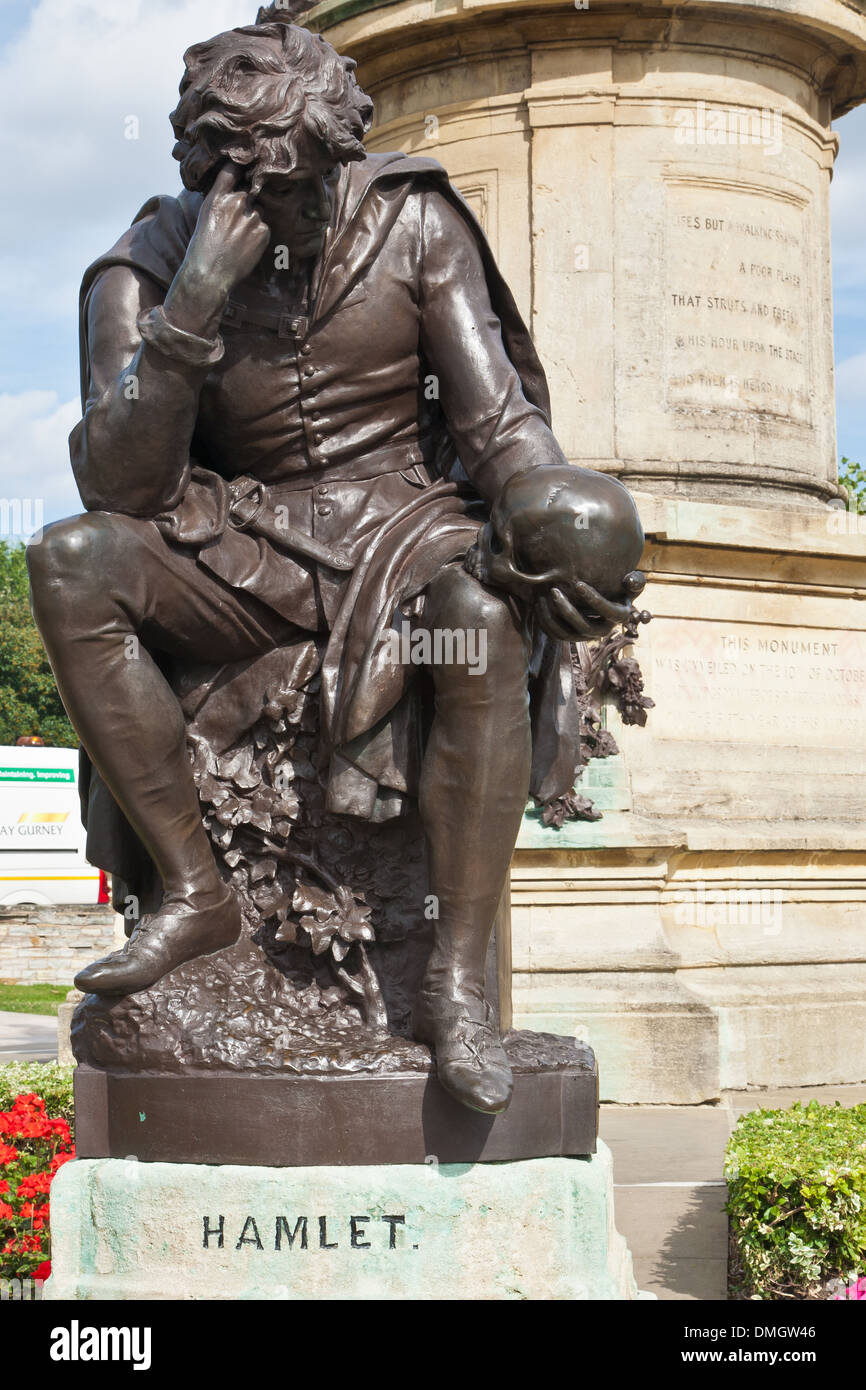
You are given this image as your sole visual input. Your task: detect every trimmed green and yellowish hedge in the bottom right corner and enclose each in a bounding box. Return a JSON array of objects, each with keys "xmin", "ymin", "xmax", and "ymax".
[{"xmin": 724, "ymin": 1101, "xmax": 866, "ymax": 1298}]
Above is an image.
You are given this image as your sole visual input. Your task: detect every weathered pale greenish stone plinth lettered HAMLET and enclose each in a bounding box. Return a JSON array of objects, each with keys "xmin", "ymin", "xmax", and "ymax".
[{"xmin": 43, "ymin": 1144, "xmax": 637, "ymax": 1302}]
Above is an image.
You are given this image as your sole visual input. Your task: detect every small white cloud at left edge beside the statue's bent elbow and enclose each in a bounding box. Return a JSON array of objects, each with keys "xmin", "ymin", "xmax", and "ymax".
[{"xmin": 0, "ymin": 391, "xmax": 83, "ymax": 539}]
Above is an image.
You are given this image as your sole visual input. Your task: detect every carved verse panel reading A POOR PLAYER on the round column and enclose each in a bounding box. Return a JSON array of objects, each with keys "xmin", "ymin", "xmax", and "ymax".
[{"xmin": 664, "ymin": 183, "xmax": 812, "ymax": 424}]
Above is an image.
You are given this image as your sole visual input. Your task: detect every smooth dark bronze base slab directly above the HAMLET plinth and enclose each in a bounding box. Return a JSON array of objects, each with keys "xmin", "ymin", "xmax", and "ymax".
[{"xmin": 75, "ymin": 1044, "xmax": 598, "ymax": 1168}]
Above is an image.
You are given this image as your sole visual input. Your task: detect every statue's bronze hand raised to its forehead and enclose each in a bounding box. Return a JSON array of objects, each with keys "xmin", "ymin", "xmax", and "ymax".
[{"xmin": 182, "ymin": 164, "xmax": 271, "ymax": 302}]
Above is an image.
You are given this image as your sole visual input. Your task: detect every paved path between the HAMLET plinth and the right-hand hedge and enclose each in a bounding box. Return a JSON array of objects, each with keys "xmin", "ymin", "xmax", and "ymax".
[{"xmin": 599, "ymin": 1086, "xmax": 866, "ymax": 1301}]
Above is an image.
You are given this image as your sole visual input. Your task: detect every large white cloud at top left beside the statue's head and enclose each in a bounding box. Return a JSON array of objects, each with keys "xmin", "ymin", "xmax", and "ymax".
[{"xmin": 0, "ymin": 0, "xmax": 257, "ymax": 320}]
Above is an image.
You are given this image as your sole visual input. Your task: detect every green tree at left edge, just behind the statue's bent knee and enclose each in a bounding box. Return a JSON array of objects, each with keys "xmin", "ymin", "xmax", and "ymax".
[{"xmin": 0, "ymin": 541, "xmax": 78, "ymax": 748}]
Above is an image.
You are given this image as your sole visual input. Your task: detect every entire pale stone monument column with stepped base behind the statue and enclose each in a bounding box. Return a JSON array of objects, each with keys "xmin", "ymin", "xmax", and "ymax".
[{"xmin": 307, "ymin": 0, "xmax": 866, "ymax": 1102}]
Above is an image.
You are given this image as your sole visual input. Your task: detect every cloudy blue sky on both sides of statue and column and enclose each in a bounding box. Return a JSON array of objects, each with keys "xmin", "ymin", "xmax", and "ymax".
[{"xmin": 0, "ymin": 0, "xmax": 866, "ymax": 521}]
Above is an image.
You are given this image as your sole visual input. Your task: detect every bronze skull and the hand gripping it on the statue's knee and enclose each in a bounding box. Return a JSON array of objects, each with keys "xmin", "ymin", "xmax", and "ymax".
[{"xmin": 464, "ymin": 464, "xmax": 646, "ymax": 642}]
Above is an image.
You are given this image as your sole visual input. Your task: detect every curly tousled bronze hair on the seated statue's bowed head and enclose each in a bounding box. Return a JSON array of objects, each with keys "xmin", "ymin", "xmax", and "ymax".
[{"xmin": 170, "ymin": 18, "xmax": 373, "ymax": 196}]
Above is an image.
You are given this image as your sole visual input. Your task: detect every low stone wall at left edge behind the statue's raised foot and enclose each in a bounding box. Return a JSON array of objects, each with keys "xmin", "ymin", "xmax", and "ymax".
[{"xmin": 0, "ymin": 906, "xmax": 115, "ymax": 987}]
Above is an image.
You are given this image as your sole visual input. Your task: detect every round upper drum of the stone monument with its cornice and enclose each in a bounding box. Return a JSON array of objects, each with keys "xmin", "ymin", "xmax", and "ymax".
[{"xmin": 307, "ymin": 0, "xmax": 866, "ymax": 506}]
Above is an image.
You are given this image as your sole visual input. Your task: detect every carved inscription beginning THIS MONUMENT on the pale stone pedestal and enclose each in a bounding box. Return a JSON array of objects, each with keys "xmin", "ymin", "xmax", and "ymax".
[{"xmin": 646, "ymin": 619, "xmax": 866, "ymax": 749}]
